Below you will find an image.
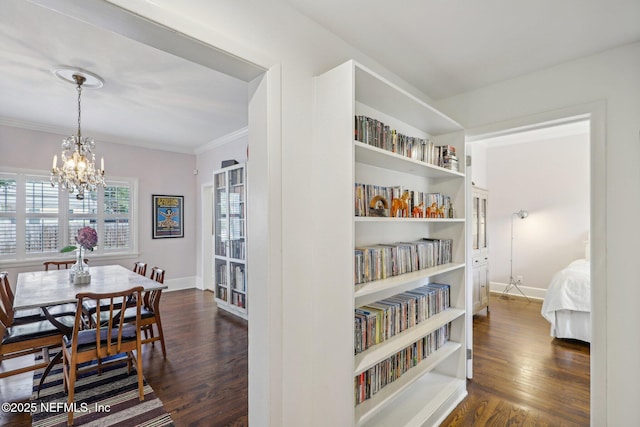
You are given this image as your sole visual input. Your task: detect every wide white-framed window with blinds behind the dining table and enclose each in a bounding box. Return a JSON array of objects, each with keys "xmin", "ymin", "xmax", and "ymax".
[{"xmin": 0, "ymin": 170, "xmax": 135, "ymax": 259}]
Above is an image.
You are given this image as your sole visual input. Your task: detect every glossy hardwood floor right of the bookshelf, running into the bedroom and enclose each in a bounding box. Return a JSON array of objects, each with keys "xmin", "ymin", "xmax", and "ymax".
[{"xmin": 442, "ymin": 297, "xmax": 590, "ymax": 427}]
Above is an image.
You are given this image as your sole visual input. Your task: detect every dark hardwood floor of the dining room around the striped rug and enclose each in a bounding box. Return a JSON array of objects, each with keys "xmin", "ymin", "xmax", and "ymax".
[{"xmin": 0, "ymin": 290, "xmax": 248, "ymax": 427}]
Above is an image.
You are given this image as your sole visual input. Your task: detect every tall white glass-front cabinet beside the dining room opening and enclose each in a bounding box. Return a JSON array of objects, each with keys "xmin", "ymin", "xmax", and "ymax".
[{"xmin": 213, "ymin": 164, "xmax": 247, "ymax": 319}]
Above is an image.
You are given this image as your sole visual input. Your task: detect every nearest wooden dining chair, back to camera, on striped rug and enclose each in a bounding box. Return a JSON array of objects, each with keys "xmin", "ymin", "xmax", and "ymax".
[{"xmin": 62, "ymin": 286, "xmax": 144, "ymax": 425}]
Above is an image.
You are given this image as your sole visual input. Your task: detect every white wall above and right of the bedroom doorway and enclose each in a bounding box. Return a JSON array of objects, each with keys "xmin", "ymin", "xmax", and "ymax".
[{"xmin": 437, "ymin": 43, "xmax": 640, "ymax": 426}]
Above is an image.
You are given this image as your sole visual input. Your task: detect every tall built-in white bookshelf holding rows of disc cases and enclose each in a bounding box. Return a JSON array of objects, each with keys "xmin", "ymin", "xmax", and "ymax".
[{"xmin": 311, "ymin": 61, "xmax": 469, "ymax": 426}]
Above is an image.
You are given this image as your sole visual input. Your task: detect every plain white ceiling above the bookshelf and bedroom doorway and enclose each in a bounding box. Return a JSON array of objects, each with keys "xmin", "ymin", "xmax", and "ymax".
[{"xmin": 287, "ymin": 0, "xmax": 640, "ymax": 99}]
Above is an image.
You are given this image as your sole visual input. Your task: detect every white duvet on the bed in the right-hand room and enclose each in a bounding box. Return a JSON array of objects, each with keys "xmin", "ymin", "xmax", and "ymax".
[{"xmin": 541, "ymin": 259, "xmax": 591, "ymax": 325}]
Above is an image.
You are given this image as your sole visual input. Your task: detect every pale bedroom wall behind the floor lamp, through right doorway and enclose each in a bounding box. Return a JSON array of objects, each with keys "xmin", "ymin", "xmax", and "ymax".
[{"xmin": 486, "ymin": 135, "xmax": 590, "ymax": 298}]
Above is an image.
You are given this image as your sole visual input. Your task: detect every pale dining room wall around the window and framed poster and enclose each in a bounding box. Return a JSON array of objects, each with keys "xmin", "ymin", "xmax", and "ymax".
[{"xmin": 0, "ymin": 126, "xmax": 198, "ymax": 289}]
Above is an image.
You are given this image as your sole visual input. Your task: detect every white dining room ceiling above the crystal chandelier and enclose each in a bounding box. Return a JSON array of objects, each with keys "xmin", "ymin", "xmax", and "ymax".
[{"xmin": 0, "ymin": 0, "xmax": 247, "ymax": 153}]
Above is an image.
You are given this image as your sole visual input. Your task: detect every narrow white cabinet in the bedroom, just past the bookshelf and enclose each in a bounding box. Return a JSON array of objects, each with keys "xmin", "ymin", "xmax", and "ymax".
[{"xmin": 471, "ymin": 187, "xmax": 490, "ymax": 314}]
